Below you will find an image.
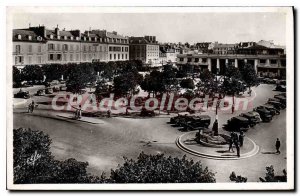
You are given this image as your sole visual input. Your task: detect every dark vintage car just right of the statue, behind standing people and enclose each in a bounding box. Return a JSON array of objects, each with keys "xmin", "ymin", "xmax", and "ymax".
[{"xmin": 223, "ymin": 116, "xmax": 250, "ymax": 132}]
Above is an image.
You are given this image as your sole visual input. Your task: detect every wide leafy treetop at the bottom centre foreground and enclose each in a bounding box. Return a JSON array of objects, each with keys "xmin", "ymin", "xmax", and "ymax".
[{"xmin": 110, "ymin": 152, "xmax": 216, "ymax": 183}]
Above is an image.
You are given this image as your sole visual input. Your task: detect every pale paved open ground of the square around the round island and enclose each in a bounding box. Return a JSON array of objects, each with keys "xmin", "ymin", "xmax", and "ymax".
[{"xmin": 14, "ymin": 85, "xmax": 286, "ymax": 182}]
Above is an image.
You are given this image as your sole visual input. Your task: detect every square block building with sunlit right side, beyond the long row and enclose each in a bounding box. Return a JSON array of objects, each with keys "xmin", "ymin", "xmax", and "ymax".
[{"xmin": 129, "ymin": 36, "xmax": 159, "ymax": 65}]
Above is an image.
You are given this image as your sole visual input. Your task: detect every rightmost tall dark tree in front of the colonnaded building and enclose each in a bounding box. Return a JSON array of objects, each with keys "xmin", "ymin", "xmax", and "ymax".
[{"xmin": 241, "ymin": 64, "xmax": 258, "ymax": 91}]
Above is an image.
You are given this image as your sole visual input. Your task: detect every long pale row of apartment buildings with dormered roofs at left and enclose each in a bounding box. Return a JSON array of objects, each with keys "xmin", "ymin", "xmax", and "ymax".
[{"xmin": 13, "ymin": 26, "xmax": 129, "ymax": 68}]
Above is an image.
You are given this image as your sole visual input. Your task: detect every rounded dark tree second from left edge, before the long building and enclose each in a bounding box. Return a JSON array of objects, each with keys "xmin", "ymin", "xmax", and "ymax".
[{"xmin": 22, "ymin": 65, "xmax": 44, "ymax": 84}]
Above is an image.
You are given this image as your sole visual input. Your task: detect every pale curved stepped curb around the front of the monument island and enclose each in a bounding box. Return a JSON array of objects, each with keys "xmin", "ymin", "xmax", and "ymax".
[{"xmin": 175, "ymin": 134, "xmax": 259, "ymax": 160}]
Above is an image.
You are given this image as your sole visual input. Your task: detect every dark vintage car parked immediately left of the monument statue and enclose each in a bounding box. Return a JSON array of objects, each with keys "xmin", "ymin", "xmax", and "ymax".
[{"xmin": 182, "ymin": 115, "xmax": 211, "ymax": 131}]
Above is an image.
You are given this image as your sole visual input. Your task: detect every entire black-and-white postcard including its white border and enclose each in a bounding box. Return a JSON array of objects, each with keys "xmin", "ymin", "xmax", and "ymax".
[{"xmin": 6, "ymin": 6, "xmax": 295, "ymax": 190}]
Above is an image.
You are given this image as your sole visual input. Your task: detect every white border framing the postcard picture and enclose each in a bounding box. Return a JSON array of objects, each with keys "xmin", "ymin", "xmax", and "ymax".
[{"xmin": 6, "ymin": 7, "xmax": 295, "ymax": 190}]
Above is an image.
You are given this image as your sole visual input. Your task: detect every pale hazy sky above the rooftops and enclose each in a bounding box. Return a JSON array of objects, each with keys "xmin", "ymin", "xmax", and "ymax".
[{"xmin": 13, "ymin": 12, "xmax": 286, "ymax": 45}]
